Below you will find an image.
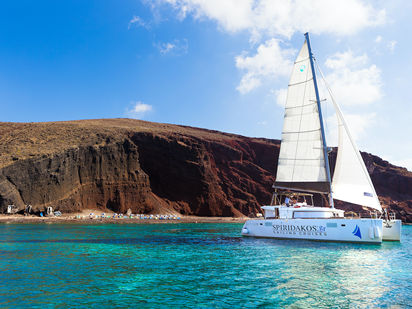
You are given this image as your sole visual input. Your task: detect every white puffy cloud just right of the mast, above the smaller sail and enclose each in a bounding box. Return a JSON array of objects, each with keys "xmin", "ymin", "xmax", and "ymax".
[{"xmin": 325, "ymin": 50, "xmax": 382, "ymax": 106}]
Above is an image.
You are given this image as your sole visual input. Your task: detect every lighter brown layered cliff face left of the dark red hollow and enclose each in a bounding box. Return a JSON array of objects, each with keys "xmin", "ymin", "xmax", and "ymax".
[{"xmin": 0, "ymin": 139, "xmax": 156, "ymax": 211}]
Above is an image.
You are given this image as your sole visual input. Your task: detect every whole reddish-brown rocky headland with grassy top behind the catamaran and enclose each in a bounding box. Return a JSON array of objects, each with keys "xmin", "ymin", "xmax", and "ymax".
[{"xmin": 0, "ymin": 119, "xmax": 412, "ymax": 222}]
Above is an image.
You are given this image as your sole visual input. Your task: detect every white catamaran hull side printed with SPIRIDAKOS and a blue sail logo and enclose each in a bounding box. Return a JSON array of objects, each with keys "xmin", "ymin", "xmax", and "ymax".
[{"xmin": 242, "ymin": 219, "xmax": 383, "ymax": 243}]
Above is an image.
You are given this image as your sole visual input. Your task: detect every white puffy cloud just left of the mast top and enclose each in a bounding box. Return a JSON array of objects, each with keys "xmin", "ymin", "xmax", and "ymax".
[{"xmin": 235, "ymin": 39, "xmax": 295, "ymax": 94}]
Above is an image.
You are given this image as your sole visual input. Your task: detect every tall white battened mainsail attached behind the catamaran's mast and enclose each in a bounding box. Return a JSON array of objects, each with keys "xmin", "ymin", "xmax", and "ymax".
[{"xmin": 274, "ymin": 36, "xmax": 330, "ymax": 193}]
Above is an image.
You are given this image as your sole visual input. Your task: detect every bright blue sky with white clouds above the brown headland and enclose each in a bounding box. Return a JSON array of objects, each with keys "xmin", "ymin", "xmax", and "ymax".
[{"xmin": 0, "ymin": 0, "xmax": 412, "ymax": 170}]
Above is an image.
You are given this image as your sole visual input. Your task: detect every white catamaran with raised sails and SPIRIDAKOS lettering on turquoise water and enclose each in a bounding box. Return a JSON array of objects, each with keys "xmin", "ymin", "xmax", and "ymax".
[{"xmin": 242, "ymin": 33, "xmax": 401, "ymax": 243}]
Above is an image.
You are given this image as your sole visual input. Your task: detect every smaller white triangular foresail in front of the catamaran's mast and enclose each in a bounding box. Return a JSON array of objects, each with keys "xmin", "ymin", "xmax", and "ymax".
[{"xmin": 318, "ymin": 62, "xmax": 382, "ymax": 212}]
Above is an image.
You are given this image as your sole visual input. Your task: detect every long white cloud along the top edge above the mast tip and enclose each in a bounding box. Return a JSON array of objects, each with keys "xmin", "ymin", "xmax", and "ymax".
[{"xmin": 157, "ymin": 0, "xmax": 386, "ymax": 37}]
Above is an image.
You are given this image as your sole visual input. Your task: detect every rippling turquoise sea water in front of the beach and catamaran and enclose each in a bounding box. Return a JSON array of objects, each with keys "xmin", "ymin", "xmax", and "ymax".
[{"xmin": 0, "ymin": 223, "xmax": 412, "ymax": 308}]
